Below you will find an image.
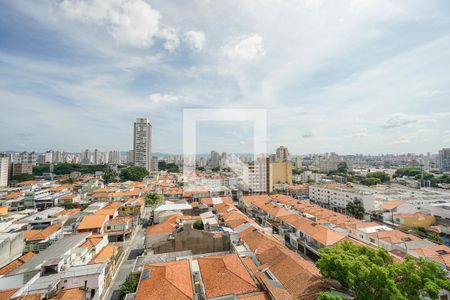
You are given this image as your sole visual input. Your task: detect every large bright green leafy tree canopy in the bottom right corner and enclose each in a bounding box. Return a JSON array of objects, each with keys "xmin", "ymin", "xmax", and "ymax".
[{"xmin": 316, "ymin": 242, "xmax": 450, "ymax": 300}]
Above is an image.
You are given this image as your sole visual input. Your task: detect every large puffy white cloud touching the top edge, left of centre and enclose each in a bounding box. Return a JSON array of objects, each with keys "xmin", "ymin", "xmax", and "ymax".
[{"xmin": 60, "ymin": 0, "xmax": 161, "ymax": 47}]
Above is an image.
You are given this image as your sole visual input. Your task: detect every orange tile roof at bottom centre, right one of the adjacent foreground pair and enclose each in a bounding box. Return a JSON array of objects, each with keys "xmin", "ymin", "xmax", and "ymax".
[{"xmin": 198, "ymin": 253, "xmax": 258, "ymax": 298}]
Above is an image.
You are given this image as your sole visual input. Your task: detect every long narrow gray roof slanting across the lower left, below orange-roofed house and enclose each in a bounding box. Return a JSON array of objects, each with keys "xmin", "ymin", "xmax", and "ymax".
[{"xmin": 11, "ymin": 233, "xmax": 91, "ymax": 274}]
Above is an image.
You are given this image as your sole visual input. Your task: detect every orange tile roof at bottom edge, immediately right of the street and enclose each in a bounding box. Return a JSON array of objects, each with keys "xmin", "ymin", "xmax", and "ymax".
[{"xmin": 135, "ymin": 259, "xmax": 194, "ymax": 300}]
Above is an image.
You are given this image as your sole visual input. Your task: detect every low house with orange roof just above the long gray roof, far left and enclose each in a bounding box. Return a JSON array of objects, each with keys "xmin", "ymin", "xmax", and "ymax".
[{"xmin": 23, "ymin": 223, "xmax": 63, "ymax": 252}]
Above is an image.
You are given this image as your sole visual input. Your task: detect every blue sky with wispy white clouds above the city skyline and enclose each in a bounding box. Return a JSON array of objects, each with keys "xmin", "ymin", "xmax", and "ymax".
[{"xmin": 0, "ymin": 0, "xmax": 450, "ymax": 154}]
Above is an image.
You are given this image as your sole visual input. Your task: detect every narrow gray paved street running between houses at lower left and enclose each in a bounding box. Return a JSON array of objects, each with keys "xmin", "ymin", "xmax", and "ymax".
[{"xmin": 103, "ymin": 208, "xmax": 149, "ymax": 300}]
